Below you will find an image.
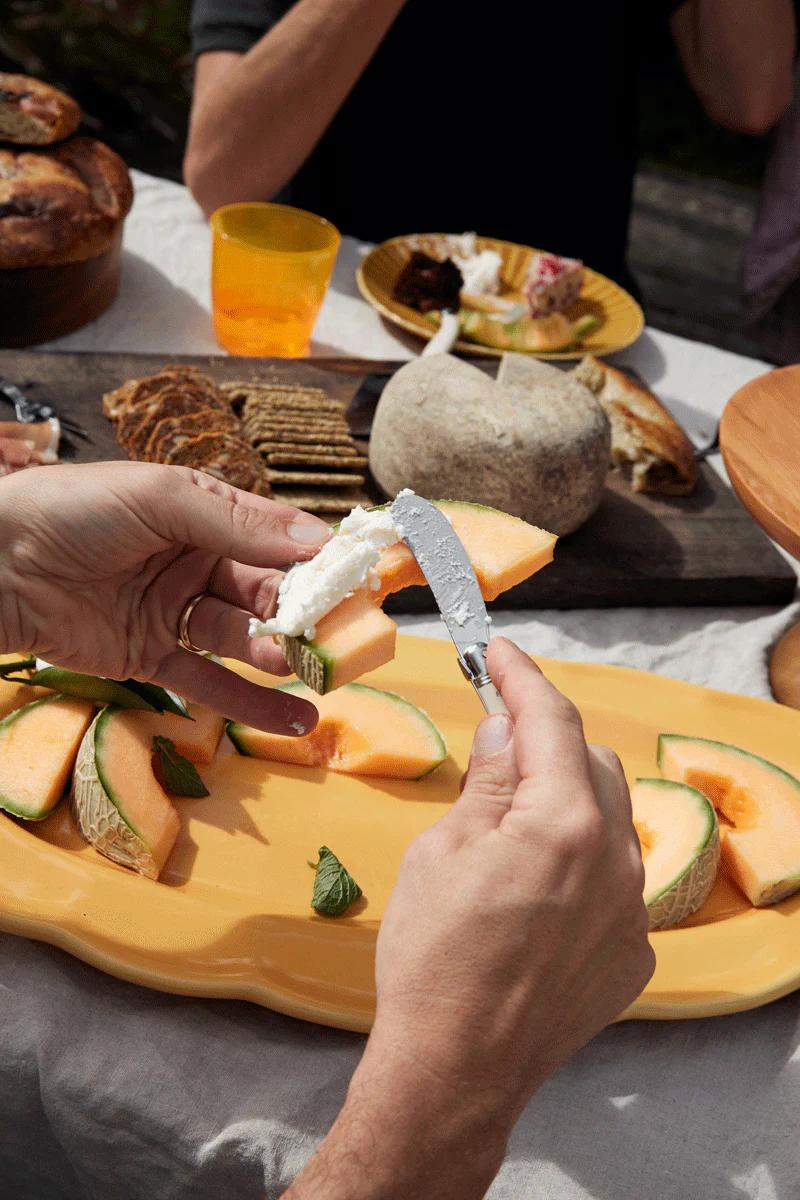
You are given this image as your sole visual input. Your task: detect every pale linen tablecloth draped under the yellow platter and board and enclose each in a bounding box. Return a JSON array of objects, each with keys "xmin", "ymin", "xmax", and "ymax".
[{"xmin": 0, "ymin": 175, "xmax": 800, "ymax": 1200}]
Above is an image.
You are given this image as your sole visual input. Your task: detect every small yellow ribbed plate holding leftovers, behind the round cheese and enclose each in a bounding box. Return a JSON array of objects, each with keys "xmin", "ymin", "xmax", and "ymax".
[{"xmin": 356, "ymin": 234, "xmax": 644, "ymax": 360}]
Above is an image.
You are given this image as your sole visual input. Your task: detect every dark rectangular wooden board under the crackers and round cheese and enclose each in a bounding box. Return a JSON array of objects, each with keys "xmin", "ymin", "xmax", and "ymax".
[{"xmin": 0, "ymin": 350, "xmax": 796, "ymax": 612}]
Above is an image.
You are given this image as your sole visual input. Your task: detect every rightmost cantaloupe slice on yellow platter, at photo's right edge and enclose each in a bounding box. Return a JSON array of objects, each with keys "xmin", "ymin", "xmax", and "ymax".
[{"xmin": 658, "ymin": 733, "xmax": 800, "ymax": 906}]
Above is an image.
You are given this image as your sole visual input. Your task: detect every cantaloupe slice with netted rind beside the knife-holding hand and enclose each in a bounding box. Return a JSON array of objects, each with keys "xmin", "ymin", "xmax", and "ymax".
[{"xmin": 631, "ymin": 779, "xmax": 720, "ymax": 929}]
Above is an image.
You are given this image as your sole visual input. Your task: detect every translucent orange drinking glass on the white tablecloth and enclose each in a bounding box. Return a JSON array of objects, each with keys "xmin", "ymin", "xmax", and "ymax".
[{"xmin": 211, "ymin": 203, "xmax": 342, "ymax": 359}]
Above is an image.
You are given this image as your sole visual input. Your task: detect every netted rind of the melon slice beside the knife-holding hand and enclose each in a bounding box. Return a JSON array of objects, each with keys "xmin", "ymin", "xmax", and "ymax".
[{"xmin": 636, "ymin": 779, "xmax": 720, "ymax": 931}]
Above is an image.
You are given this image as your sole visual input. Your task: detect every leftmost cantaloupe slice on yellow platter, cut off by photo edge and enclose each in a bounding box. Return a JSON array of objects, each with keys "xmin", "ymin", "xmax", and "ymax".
[{"xmin": 0, "ymin": 695, "xmax": 95, "ymax": 821}]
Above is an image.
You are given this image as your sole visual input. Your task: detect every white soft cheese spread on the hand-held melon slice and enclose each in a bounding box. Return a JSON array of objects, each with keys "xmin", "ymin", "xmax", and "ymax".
[{"xmin": 249, "ymin": 506, "xmax": 402, "ymax": 637}]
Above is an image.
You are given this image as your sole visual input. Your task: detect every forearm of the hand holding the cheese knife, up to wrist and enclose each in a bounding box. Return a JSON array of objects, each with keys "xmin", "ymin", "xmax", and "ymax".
[{"xmin": 284, "ymin": 1022, "xmax": 513, "ymax": 1200}]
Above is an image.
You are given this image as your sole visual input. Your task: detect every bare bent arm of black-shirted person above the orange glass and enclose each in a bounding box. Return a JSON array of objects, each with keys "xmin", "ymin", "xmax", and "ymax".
[{"xmin": 185, "ymin": 0, "xmax": 403, "ymax": 212}]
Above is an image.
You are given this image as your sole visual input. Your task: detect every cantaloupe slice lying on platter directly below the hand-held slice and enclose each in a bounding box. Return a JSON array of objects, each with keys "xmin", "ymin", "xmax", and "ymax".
[{"xmin": 228, "ymin": 683, "xmax": 447, "ymax": 779}]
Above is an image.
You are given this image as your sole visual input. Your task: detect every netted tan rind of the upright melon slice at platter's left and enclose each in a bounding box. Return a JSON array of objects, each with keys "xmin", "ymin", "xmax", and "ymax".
[{"xmin": 72, "ymin": 708, "xmax": 158, "ymax": 880}]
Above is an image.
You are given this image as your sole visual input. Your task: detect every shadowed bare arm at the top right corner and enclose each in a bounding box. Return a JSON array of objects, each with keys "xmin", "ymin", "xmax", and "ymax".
[{"xmin": 673, "ymin": 0, "xmax": 795, "ymax": 133}]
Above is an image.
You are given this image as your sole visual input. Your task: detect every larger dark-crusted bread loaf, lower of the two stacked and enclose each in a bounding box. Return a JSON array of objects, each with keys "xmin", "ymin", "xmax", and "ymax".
[{"xmin": 0, "ymin": 138, "xmax": 133, "ymax": 269}]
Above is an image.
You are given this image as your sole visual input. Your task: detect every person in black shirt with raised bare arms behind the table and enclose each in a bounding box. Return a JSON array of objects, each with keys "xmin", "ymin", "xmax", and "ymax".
[{"xmin": 185, "ymin": 0, "xmax": 794, "ymax": 282}]
